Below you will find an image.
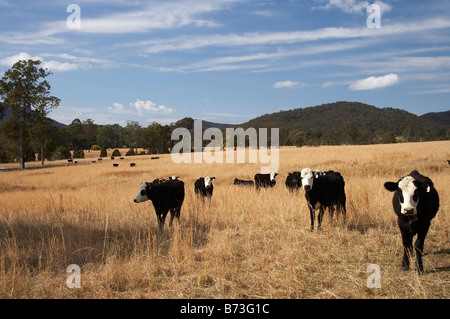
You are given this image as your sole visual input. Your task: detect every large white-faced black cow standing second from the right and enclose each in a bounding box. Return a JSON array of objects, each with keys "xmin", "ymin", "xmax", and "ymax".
[{"xmin": 301, "ymin": 168, "xmax": 347, "ymax": 231}]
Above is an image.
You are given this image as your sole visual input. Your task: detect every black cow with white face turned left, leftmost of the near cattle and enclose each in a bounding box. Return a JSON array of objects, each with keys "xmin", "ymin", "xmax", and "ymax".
[{"xmin": 134, "ymin": 179, "xmax": 184, "ymax": 229}]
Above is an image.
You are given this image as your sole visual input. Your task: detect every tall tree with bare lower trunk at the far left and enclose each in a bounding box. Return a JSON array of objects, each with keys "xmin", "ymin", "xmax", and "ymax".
[{"xmin": 0, "ymin": 60, "xmax": 59, "ymax": 169}]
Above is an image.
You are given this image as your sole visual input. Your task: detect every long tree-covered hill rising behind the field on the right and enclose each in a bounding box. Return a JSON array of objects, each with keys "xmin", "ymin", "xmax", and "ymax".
[{"xmin": 239, "ymin": 102, "xmax": 450, "ymax": 145}]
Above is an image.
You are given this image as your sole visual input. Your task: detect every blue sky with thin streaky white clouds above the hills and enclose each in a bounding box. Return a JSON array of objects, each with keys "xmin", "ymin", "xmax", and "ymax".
[{"xmin": 0, "ymin": 0, "xmax": 450, "ymax": 126}]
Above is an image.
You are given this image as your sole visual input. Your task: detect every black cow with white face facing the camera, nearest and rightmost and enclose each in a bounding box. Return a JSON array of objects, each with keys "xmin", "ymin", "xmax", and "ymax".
[{"xmin": 384, "ymin": 170, "xmax": 439, "ymax": 274}]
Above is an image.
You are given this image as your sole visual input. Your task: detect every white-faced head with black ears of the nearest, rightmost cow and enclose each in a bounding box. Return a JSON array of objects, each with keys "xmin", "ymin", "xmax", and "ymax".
[{"xmin": 384, "ymin": 175, "xmax": 432, "ymax": 215}]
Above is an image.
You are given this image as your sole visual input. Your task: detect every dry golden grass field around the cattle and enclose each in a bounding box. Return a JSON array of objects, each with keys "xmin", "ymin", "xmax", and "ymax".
[{"xmin": 0, "ymin": 141, "xmax": 450, "ymax": 298}]
